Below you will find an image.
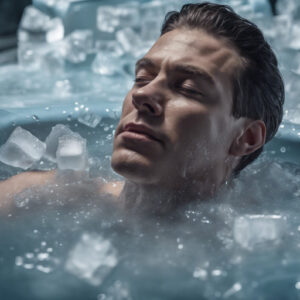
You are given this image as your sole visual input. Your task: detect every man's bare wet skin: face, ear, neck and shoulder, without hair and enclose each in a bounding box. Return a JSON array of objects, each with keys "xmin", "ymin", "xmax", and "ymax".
[{"xmin": 0, "ymin": 29, "xmax": 266, "ymax": 212}]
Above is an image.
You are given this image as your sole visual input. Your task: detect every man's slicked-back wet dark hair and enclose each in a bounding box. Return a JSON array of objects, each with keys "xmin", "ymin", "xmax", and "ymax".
[{"xmin": 161, "ymin": 2, "xmax": 284, "ymax": 174}]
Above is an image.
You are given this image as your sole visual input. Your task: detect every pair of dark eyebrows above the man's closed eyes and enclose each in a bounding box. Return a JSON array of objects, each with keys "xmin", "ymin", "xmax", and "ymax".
[{"xmin": 135, "ymin": 57, "xmax": 215, "ymax": 85}]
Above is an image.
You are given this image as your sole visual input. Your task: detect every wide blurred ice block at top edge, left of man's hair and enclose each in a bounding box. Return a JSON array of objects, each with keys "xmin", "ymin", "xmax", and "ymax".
[{"xmin": 97, "ymin": 6, "xmax": 139, "ymax": 32}]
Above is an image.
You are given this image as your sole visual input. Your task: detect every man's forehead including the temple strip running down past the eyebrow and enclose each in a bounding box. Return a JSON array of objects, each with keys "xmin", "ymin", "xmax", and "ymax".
[{"xmin": 145, "ymin": 29, "xmax": 243, "ymax": 103}]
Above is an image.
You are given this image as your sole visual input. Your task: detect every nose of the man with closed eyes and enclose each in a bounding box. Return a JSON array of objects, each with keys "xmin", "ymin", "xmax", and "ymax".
[{"xmin": 132, "ymin": 82, "xmax": 164, "ymax": 116}]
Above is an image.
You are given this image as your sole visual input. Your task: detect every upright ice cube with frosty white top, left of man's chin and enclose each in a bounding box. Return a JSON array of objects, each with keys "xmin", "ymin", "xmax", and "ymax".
[{"xmin": 56, "ymin": 134, "xmax": 87, "ymax": 171}]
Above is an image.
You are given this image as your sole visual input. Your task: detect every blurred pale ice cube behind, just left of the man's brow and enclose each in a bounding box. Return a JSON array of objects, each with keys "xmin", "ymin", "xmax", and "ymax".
[{"xmin": 92, "ymin": 53, "xmax": 120, "ymax": 76}]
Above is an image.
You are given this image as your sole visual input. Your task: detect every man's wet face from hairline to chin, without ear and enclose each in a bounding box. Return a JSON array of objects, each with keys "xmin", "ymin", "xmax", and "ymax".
[{"xmin": 112, "ymin": 29, "xmax": 245, "ymax": 188}]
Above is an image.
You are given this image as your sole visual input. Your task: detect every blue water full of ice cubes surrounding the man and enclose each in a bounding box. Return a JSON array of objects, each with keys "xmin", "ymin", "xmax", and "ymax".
[{"xmin": 0, "ymin": 1, "xmax": 300, "ymax": 300}]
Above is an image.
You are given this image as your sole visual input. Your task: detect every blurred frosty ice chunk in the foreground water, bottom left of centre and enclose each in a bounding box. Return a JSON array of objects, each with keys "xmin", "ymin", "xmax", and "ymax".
[{"xmin": 65, "ymin": 233, "xmax": 118, "ymax": 286}]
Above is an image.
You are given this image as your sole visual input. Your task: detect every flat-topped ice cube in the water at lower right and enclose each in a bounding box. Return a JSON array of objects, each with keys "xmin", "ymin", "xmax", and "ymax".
[{"xmin": 233, "ymin": 215, "xmax": 285, "ymax": 250}]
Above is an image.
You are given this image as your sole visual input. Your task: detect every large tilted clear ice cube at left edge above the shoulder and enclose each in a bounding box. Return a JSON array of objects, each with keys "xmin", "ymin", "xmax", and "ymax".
[{"xmin": 0, "ymin": 127, "xmax": 46, "ymax": 169}]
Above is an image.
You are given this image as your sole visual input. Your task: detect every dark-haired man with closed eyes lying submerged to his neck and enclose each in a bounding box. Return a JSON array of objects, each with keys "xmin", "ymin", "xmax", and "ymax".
[{"xmin": 0, "ymin": 3, "xmax": 284, "ymax": 212}]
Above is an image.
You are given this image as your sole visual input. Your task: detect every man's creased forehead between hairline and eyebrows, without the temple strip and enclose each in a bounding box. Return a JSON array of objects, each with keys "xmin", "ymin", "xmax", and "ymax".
[{"xmin": 145, "ymin": 29, "xmax": 242, "ymax": 75}]
